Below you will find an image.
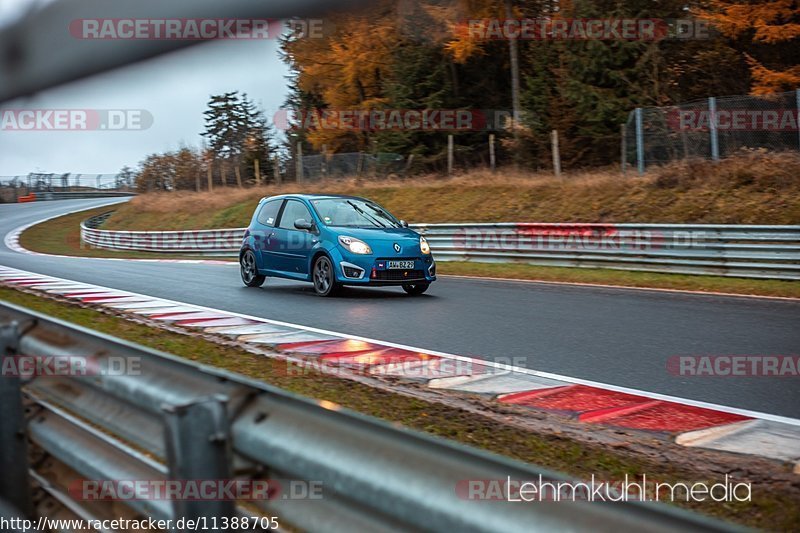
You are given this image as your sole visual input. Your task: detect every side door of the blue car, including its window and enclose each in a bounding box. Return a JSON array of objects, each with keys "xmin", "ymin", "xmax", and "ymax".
[{"xmin": 273, "ymin": 199, "xmax": 317, "ymax": 279}]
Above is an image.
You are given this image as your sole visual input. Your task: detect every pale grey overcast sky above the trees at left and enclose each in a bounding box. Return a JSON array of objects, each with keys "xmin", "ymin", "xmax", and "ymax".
[{"xmin": 0, "ymin": 0, "xmax": 289, "ymax": 176}]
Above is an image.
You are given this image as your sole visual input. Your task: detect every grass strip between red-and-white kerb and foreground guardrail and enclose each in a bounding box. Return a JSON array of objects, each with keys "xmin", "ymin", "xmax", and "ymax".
[{"xmin": 0, "ymin": 287, "xmax": 800, "ymax": 531}]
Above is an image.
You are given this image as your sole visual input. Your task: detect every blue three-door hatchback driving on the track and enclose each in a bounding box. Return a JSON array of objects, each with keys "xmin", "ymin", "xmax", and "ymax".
[{"xmin": 239, "ymin": 194, "xmax": 436, "ymax": 296}]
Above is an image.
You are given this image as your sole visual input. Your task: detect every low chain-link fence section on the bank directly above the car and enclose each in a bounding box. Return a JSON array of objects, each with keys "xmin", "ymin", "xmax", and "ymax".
[{"xmin": 294, "ymin": 152, "xmax": 406, "ymax": 181}]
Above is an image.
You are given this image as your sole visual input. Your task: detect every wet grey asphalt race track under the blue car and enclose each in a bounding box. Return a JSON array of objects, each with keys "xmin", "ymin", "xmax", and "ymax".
[{"xmin": 0, "ymin": 199, "xmax": 800, "ymax": 418}]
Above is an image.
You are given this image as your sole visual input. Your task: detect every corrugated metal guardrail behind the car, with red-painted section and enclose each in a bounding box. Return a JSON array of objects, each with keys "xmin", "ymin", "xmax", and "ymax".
[{"xmin": 81, "ymin": 216, "xmax": 800, "ymax": 280}]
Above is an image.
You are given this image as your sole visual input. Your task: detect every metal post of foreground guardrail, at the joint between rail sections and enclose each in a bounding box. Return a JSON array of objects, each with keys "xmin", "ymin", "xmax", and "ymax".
[{"xmin": 163, "ymin": 395, "xmax": 236, "ymax": 531}]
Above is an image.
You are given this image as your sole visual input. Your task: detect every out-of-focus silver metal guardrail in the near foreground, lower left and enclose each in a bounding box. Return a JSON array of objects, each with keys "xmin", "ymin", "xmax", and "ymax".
[{"xmin": 0, "ymin": 303, "xmax": 727, "ymax": 532}]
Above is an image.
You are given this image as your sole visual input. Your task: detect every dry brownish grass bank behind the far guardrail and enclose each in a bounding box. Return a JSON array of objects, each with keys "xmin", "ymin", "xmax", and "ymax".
[{"xmin": 105, "ymin": 152, "xmax": 800, "ymax": 229}]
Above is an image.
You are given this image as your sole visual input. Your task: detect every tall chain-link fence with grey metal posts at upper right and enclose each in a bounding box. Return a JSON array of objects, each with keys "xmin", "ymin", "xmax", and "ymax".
[{"xmin": 622, "ymin": 89, "xmax": 800, "ymax": 172}]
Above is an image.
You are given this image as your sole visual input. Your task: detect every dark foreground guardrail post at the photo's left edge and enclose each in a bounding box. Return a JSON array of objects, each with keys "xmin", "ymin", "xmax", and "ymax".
[{"xmin": 0, "ymin": 322, "xmax": 33, "ymax": 516}]
